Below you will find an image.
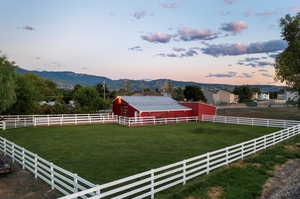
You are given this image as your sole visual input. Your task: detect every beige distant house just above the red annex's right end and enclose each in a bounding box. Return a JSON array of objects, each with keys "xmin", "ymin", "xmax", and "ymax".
[{"xmin": 203, "ymin": 89, "xmax": 239, "ymax": 105}]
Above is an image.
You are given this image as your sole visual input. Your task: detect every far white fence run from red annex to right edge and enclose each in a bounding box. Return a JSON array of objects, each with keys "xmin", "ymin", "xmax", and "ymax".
[{"xmin": 201, "ymin": 115, "xmax": 300, "ymax": 128}]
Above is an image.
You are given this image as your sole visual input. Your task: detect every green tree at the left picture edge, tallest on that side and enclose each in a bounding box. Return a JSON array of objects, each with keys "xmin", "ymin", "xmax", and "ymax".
[{"xmin": 0, "ymin": 56, "xmax": 16, "ymax": 113}]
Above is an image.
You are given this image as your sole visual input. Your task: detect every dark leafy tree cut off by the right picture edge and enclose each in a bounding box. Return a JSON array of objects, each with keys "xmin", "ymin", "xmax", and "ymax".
[{"xmin": 275, "ymin": 13, "xmax": 300, "ymax": 105}]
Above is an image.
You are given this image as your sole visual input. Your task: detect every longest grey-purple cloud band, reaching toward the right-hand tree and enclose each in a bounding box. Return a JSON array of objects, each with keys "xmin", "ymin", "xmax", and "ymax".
[{"xmin": 201, "ymin": 40, "xmax": 287, "ymax": 57}]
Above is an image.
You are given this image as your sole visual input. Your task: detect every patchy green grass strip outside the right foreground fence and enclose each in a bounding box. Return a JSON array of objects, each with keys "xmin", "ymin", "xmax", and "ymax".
[{"xmin": 156, "ymin": 131, "xmax": 300, "ymax": 199}]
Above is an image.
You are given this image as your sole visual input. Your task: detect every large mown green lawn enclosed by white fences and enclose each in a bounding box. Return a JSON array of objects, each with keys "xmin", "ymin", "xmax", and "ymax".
[{"xmin": 0, "ymin": 123, "xmax": 278, "ymax": 184}]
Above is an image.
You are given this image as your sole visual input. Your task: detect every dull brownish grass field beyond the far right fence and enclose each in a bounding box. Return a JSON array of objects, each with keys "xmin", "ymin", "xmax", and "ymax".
[{"xmin": 218, "ymin": 107, "xmax": 300, "ymax": 120}]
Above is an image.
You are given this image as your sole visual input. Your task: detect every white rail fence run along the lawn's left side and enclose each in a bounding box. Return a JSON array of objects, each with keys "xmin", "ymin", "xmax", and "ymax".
[{"xmin": 0, "ymin": 137, "xmax": 96, "ymax": 198}]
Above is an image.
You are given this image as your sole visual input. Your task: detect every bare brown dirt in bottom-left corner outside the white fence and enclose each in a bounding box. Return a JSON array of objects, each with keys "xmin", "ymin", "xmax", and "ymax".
[{"xmin": 0, "ymin": 154, "xmax": 62, "ymax": 199}]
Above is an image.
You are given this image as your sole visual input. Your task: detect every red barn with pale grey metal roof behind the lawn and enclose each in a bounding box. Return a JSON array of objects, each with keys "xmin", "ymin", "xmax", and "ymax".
[{"xmin": 113, "ymin": 96, "xmax": 215, "ymax": 118}]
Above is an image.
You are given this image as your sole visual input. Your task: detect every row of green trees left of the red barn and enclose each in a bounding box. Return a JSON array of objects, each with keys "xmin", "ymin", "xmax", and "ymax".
[{"xmin": 0, "ymin": 56, "xmax": 115, "ymax": 114}]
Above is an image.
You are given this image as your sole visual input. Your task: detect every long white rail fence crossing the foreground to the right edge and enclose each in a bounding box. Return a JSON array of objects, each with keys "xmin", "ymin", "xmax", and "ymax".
[{"xmin": 60, "ymin": 125, "xmax": 300, "ymax": 199}]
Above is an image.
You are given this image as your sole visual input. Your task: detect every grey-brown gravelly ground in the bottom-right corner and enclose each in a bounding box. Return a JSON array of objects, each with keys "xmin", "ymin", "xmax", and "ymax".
[{"xmin": 260, "ymin": 159, "xmax": 300, "ymax": 199}]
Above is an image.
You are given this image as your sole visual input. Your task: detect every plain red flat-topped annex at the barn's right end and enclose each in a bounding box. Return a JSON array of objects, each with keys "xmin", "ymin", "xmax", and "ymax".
[{"xmin": 180, "ymin": 102, "xmax": 216, "ymax": 117}]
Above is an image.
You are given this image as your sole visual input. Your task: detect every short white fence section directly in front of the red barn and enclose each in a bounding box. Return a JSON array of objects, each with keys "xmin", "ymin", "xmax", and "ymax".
[{"xmin": 119, "ymin": 116, "xmax": 199, "ymax": 126}]
